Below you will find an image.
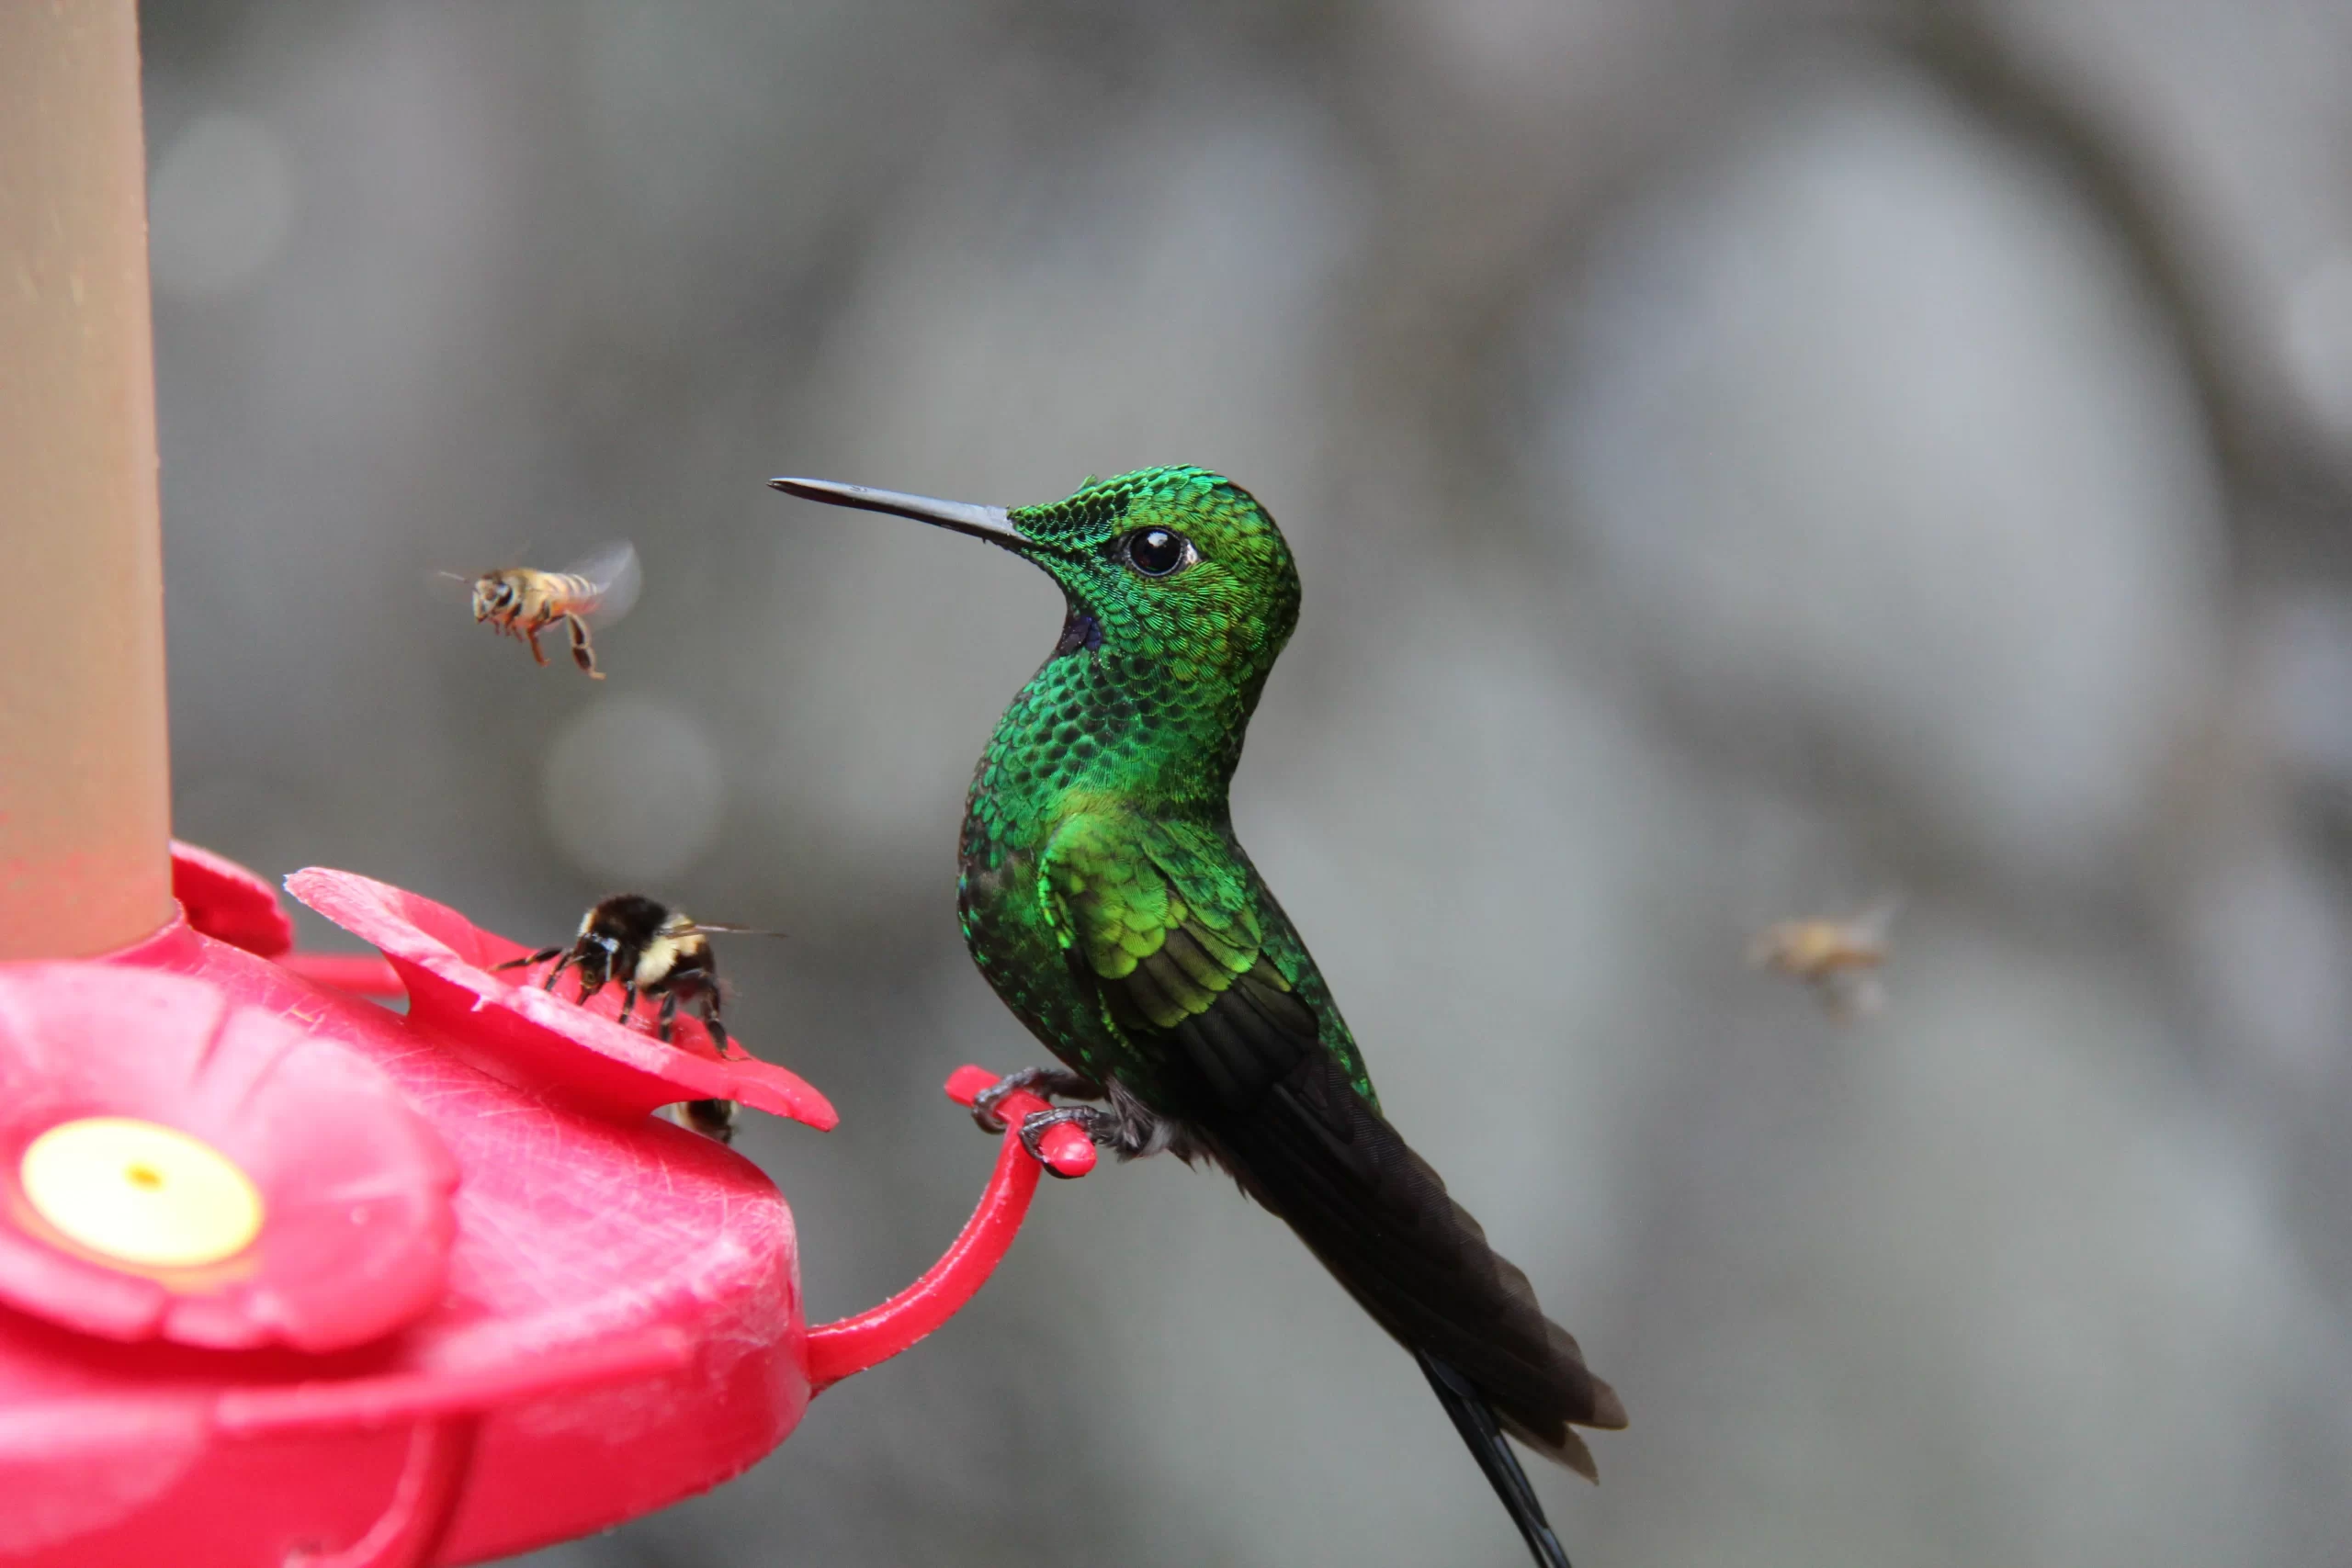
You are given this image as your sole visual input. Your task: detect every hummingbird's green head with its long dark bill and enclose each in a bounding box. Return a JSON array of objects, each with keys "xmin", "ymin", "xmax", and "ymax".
[{"xmin": 769, "ymin": 468, "xmax": 1298, "ymax": 701}]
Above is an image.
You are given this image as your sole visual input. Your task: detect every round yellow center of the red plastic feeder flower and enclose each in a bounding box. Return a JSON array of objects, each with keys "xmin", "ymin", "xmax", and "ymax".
[{"xmin": 17, "ymin": 1117, "xmax": 261, "ymax": 1267}]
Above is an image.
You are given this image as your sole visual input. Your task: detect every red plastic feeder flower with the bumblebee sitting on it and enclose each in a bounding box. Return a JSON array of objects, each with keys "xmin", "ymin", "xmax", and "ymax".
[{"xmin": 287, "ymin": 865, "xmax": 840, "ymax": 1131}]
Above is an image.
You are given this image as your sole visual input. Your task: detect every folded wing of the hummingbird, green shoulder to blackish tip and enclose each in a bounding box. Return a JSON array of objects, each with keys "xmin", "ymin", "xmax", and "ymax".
[{"xmin": 1040, "ymin": 813, "xmax": 1625, "ymax": 1500}]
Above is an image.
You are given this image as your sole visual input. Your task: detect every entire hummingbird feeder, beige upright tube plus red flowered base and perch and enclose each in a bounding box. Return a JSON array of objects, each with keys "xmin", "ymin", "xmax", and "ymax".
[{"xmin": 0, "ymin": 0, "xmax": 1093, "ymax": 1568}]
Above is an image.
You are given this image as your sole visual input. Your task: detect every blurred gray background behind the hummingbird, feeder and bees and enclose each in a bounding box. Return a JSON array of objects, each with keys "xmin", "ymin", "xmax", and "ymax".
[{"xmin": 146, "ymin": 0, "xmax": 2352, "ymax": 1568}]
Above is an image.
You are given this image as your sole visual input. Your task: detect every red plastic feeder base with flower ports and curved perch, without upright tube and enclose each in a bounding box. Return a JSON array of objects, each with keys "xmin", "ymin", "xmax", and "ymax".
[{"xmin": 0, "ymin": 846, "xmax": 1093, "ymax": 1568}]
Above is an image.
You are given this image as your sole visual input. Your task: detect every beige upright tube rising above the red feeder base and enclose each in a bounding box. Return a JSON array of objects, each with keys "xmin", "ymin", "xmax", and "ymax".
[{"xmin": 0, "ymin": 0, "xmax": 172, "ymax": 959}]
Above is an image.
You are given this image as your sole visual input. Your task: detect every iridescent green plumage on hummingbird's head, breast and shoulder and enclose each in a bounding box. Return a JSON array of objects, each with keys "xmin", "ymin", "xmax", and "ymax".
[{"xmin": 959, "ymin": 468, "xmax": 1371, "ymax": 1110}]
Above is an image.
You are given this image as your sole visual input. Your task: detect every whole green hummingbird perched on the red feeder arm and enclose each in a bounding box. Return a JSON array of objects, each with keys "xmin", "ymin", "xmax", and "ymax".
[{"xmin": 772, "ymin": 468, "xmax": 1625, "ymax": 1568}]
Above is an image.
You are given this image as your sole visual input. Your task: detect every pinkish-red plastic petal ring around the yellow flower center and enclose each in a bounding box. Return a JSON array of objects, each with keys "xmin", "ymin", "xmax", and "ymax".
[{"xmin": 0, "ymin": 964, "xmax": 457, "ymax": 1352}]
